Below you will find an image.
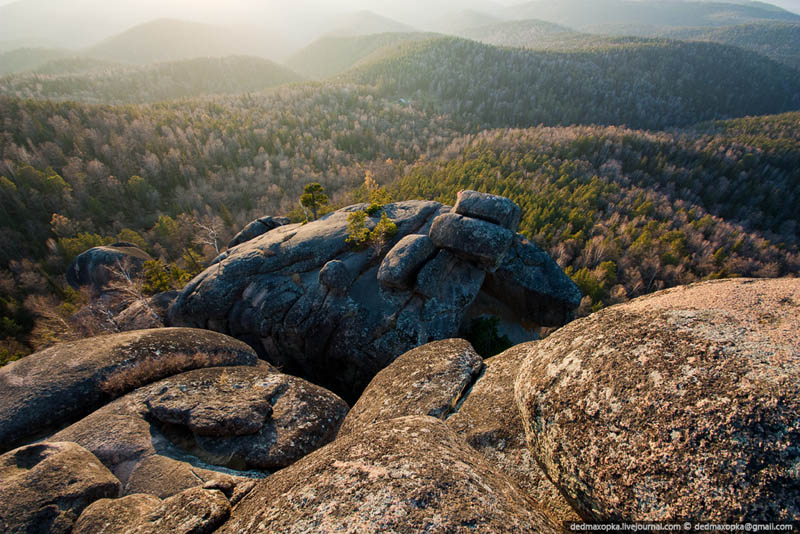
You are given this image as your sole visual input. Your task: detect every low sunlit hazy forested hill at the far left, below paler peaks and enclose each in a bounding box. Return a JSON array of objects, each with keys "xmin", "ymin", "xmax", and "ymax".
[{"xmin": 0, "ymin": 56, "xmax": 302, "ymax": 104}]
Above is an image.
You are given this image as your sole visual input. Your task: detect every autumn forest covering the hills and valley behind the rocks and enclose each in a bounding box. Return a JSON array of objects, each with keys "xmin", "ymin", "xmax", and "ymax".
[{"xmin": 0, "ymin": 5, "xmax": 800, "ymax": 365}]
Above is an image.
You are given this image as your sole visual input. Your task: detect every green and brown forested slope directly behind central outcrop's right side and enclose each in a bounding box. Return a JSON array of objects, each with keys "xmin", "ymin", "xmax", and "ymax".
[{"xmin": 393, "ymin": 113, "xmax": 800, "ymax": 313}]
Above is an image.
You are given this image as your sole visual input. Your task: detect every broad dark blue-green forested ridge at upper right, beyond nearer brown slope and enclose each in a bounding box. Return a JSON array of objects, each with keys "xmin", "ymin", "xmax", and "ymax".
[{"xmin": 345, "ymin": 38, "xmax": 800, "ymax": 128}]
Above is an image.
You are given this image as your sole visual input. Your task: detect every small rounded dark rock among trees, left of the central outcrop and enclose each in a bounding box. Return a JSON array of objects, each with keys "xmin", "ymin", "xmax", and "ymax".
[{"xmin": 67, "ymin": 242, "xmax": 153, "ymax": 290}]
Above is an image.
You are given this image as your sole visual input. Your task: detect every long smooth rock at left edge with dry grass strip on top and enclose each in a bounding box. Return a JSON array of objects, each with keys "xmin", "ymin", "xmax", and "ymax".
[{"xmin": 0, "ymin": 328, "xmax": 258, "ymax": 451}]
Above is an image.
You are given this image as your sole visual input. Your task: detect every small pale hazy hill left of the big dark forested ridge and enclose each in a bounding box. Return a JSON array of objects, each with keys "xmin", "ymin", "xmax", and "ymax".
[{"xmin": 285, "ymin": 32, "xmax": 435, "ymax": 80}]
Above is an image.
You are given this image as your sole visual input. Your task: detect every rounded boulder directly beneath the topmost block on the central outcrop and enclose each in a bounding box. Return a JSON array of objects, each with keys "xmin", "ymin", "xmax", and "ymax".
[{"xmin": 430, "ymin": 213, "xmax": 514, "ymax": 272}]
